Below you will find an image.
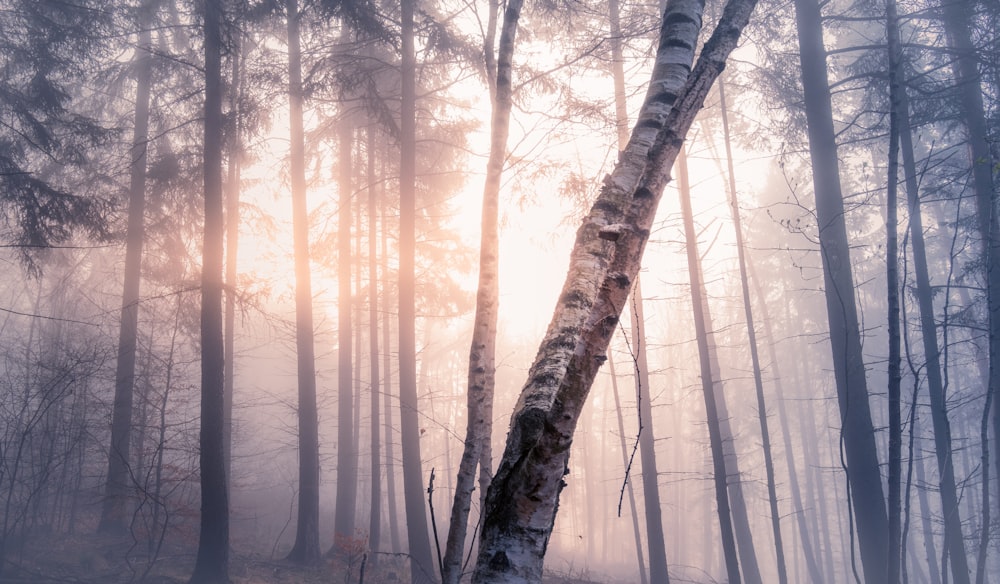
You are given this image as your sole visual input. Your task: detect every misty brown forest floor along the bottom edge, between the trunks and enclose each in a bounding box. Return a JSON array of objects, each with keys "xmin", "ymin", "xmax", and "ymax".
[{"xmin": 0, "ymin": 534, "xmax": 602, "ymax": 584}]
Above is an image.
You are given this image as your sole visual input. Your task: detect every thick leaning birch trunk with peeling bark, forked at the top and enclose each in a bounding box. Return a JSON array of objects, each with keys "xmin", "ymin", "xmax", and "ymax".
[{"xmin": 473, "ymin": 0, "xmax": 754, "ymax": 583}]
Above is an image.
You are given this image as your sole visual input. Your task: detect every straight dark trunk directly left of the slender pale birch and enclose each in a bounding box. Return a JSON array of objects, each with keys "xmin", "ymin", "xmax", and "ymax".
[{"xmin": 399, "ymin": 0, "xmax": 436, "ymax": 584}]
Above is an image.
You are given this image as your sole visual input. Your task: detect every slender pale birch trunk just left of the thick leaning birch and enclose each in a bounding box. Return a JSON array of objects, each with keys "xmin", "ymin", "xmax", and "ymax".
[{"xmin": 441, "ymin": 0, "xmax": 522, "ymax": 584}]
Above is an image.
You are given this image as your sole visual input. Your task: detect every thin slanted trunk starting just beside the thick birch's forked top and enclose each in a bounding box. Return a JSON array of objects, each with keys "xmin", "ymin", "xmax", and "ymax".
[{"xmin": 719, "ymin": 79, "xmax": 788, "ymax": 584}]
